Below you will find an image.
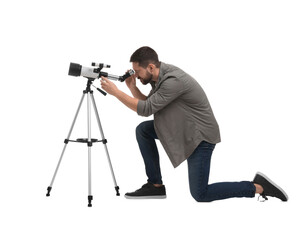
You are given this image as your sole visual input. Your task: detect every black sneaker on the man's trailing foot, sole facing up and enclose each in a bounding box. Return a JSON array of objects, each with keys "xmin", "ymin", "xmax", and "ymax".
[{"xmin": 253, "ymin": 172, "xmax": 288, "ymax": 202}]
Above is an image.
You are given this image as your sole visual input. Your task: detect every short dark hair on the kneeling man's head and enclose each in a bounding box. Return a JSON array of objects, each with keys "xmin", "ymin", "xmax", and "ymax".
[{"xmin": 130, "ymin": 47, "xmax": 160, "ymax": 68}]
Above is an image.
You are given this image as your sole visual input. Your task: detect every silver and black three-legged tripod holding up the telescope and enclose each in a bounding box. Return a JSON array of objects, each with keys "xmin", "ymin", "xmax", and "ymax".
[{"xmin": 46, "ymin": 78, "xmax": 120, "ymax": 207}]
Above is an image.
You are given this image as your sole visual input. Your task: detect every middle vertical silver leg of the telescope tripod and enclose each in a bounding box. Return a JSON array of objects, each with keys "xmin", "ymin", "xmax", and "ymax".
[{"xmin": 87, "ymin": 92, "xmax": 93, "ymax": 207}]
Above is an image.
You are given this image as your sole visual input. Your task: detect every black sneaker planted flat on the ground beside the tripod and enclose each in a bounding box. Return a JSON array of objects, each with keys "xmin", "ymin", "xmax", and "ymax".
[{"xmin": 125, "ymin": 183, "xmax": 166, "ymax": 199}]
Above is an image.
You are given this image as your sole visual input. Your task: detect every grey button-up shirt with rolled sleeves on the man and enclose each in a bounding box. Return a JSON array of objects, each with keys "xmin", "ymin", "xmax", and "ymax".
[{"xmin": 137, "ymin": 62, "xmax": 220, "ymax": 167}]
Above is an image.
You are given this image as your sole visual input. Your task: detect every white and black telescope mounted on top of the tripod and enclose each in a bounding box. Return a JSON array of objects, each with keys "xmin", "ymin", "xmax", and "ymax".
[{"xmin": 68, "ymin": 62, "xmax": 135, "ymax": 82}]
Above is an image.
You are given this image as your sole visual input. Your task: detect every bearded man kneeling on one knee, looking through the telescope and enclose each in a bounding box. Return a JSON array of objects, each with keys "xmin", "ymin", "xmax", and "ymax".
[{"xmin": 101, "ymin": 47, "xmax": 288, "ymax": 202}]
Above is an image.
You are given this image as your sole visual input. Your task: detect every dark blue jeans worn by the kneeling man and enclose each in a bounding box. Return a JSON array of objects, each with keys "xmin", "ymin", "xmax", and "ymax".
[{"xmin": 136, "ymin": 121, "xmax": 256, "ymax": 202}]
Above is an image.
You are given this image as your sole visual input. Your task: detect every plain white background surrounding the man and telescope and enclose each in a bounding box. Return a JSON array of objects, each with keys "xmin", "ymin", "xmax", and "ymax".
[{"xmin": 0, "ymin": 0, "xmax": 308, "ymax": 240}]
